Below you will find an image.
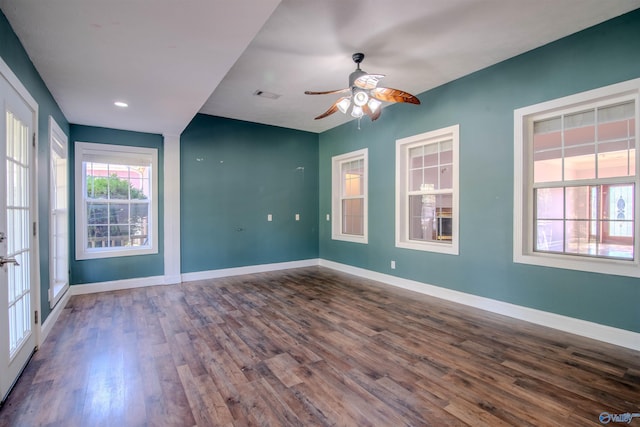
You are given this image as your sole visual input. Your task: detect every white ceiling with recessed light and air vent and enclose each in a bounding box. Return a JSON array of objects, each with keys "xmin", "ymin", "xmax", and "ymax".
[{"xmin": 0, "ymin": 0, "xmax": 640, "ymax": 134}]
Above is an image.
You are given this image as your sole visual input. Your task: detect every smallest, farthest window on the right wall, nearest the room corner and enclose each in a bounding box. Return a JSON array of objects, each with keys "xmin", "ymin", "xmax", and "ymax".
[{"xmin": 331, "ymin": 148, "xmax": 368, "ymax": 243}]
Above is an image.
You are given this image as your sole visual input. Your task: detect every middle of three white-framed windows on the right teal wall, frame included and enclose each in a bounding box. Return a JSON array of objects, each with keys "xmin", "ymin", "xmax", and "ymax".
[{"xmin": 396, "ymin": 125, "xmax": 459, "ymax": 255}]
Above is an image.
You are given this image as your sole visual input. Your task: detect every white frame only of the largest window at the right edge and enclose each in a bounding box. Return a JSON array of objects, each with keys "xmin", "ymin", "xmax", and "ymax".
[{"xmin": 513, "ymin": 79, "xmax": 640, "ymax": 277}]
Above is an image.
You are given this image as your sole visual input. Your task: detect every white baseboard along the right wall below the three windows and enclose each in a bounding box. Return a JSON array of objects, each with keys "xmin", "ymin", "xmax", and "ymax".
[{"xmin": 320, "ymin": 259, "xmax": 640, "ymax": 351}]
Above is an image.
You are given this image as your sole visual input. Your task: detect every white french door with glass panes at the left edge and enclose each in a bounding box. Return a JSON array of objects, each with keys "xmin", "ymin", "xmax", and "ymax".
[{"xmin": 0, "ymin": 70, "xmax": 37, "ymax": 402}]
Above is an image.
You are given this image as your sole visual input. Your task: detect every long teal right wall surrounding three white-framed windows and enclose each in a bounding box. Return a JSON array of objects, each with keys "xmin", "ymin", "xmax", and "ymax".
[{"xmin": 319, "ymin": 10, "xmax": 640, "ymax": 332}]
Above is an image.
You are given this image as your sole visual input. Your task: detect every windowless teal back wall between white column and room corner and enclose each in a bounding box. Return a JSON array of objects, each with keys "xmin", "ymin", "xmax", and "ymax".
[{"xmin": 180, "ymin": 114, "xmax": 318, "ymax": 273}]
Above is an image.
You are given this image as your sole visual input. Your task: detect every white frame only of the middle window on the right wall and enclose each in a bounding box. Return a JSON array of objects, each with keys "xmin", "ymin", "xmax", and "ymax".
[{"xmin": 396, "ymin": 125, "xmax": 460, "ymax": 255}]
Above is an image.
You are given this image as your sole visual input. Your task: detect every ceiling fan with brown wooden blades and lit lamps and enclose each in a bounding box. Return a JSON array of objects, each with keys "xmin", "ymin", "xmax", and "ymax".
[{"xmin": 305, "ymin": 53, "xmax": 420, "ymax": 121}]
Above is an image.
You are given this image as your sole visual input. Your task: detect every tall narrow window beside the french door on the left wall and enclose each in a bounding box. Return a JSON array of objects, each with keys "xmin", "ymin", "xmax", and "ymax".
[{"xmin": 49, "ymin": 116, "xmax": 69, "ymax": 307}]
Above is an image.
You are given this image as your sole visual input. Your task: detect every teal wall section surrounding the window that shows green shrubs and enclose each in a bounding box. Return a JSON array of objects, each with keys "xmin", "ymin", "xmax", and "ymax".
[{"xmin": 69, "ymin": 124, "xmax": 164, "ymax": 285}]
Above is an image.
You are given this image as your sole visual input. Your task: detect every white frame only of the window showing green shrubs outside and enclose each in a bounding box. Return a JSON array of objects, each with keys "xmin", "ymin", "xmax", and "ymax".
[{"xmin": 74, "ymin": 141, "xmax": 158, "ymax": 260}]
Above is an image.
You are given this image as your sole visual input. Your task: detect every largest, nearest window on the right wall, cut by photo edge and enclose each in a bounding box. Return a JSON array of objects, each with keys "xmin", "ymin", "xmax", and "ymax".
[{"xmin": 514, "ymin": 79, "xmax": 640, "ymax": 276}]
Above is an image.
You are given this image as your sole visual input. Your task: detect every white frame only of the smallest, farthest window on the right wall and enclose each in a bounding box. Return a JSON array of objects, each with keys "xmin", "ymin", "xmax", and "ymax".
[{"xmin": 331, "ymin": 148, "xmax": 369, "ymax": 244}]
